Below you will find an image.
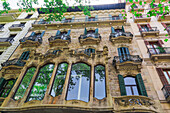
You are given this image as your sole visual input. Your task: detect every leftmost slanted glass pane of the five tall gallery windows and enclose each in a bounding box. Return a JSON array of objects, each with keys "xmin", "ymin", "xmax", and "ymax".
[{"xmin": 14, "ymin": 67, "xmax": 36, "ymax": 100}]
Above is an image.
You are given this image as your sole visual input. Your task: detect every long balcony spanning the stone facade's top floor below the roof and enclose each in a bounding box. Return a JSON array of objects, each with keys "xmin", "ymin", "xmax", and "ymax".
[{"xmin": 32, "ymin": 17, "xmax": 126, "ymax": 29}]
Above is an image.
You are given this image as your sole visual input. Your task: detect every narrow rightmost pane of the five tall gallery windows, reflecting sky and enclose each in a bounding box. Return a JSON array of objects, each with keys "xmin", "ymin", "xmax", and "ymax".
[{"xmin": 94, "ymin": 65, "xmax": 106, "ymax": 99}]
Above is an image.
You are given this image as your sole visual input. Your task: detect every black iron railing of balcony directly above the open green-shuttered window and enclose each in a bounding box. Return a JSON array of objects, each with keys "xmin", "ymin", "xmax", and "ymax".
[{"xmin": 113, "ymin": 54, "xmax": 142, "ymax": 65}]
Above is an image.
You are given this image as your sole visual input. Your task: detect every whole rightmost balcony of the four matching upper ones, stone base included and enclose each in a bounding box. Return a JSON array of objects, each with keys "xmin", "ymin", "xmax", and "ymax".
[{"xmin": 109, "ymin": 32, "xmax": 133, "ymax": 44}]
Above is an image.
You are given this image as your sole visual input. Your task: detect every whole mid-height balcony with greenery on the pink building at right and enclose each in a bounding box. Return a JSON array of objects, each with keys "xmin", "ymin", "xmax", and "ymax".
[{"xmin": 148, "ymin": 47, "xmax": 170, "ymax": 61}]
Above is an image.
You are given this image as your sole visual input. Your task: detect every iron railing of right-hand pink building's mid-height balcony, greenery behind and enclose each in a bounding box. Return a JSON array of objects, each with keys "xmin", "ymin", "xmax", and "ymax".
[{"xmin": 148, "ymin": 47, "xmax": 170, "ymax": 55}]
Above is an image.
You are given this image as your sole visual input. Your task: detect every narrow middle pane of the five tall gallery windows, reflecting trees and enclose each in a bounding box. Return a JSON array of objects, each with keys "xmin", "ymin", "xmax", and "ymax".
[{"xmin": 51, "ymin": 63, "xmax": 68, "ymax": 97}]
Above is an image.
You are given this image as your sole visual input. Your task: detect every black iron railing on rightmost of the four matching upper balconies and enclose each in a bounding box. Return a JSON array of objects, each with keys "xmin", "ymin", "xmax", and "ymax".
[{"xmin": 110, "ymin": 32, "xmax": 133, "ymax": 39}]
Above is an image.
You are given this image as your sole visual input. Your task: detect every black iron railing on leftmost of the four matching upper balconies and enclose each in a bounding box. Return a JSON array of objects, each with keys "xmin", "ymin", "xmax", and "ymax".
[{"xmin": 19, "ymin": 36, "xmax": 42, "ymax": 43}]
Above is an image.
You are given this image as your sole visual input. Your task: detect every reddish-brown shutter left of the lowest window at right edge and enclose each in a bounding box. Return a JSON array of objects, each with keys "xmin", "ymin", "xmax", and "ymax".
[{"xmin": 156, "ymin": 68, "xmax": 169, "ymax": 85}]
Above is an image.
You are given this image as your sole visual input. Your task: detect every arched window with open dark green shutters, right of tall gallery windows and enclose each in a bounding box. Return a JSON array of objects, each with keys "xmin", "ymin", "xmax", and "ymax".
[{"xmin": 118, "ymin": 74, "xmax": 148, "ymax": 96}]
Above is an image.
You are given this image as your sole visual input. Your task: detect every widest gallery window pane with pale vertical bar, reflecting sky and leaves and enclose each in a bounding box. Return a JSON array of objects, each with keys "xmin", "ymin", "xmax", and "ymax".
[{"xmin": 66, "ymin": 63, "xmax": 91, "ymax": 102}]
